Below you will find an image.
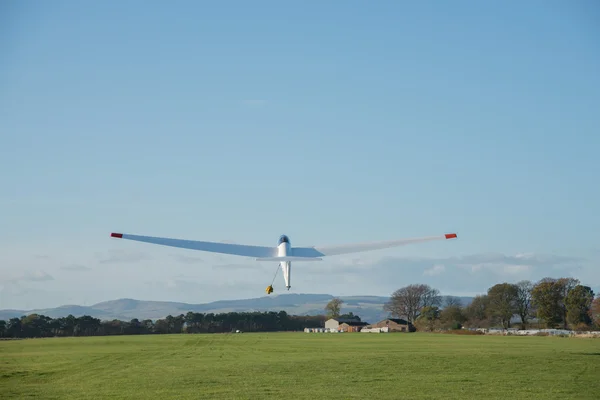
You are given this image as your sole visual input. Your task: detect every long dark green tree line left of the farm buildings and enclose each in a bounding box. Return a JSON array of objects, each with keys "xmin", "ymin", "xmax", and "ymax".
[{"xmin": 0, "ymin": 311, "xmax": 325, "ymax": 338}]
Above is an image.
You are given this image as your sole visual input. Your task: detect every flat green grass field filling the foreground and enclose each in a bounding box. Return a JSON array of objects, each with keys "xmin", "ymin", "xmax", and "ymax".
[{"xmin": 0, "ymin": 333, "xmax": 600, "ymax": 400}]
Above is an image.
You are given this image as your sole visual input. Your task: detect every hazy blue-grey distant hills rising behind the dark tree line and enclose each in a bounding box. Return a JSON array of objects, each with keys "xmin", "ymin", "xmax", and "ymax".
[{"xmin": 0, "ymin": 294, "xmax": 472, "ymax": 323}]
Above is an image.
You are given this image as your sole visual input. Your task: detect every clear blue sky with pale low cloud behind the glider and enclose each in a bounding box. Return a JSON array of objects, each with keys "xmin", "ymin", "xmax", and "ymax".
[{"xmin": 0, "ymin": 1, "xmax": 600, "ymax": 308}]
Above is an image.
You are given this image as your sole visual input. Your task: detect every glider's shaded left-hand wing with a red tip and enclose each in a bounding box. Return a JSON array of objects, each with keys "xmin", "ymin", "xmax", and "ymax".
[{"xmin": 110, "ymin": 233, "xmax": 277, "ymax": 258}]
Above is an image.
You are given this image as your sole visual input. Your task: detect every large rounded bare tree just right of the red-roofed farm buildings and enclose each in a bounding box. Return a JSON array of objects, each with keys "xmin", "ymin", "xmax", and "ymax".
[{"xmin": 383, "ymin": 284, "xmax": 442, "ymax": 323}]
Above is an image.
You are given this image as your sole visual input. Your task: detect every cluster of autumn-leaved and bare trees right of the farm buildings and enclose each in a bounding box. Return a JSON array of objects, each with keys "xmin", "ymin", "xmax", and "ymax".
[{"xmin": 384, "ymin": 278, "xmax": 600, "ymax": 331}]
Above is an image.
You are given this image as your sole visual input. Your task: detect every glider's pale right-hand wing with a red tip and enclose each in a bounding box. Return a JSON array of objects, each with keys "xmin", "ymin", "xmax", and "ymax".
[{"xmin": 292, "ymin": 233, "xmax": 456, "ymax": 257}]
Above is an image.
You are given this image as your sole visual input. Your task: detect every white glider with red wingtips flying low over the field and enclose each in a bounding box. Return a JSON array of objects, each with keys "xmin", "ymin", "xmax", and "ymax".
[{"xmin": 111, "ymin": 233, "xmax": 457, "ymax": 294}]
